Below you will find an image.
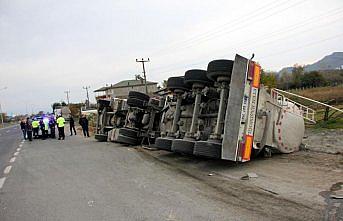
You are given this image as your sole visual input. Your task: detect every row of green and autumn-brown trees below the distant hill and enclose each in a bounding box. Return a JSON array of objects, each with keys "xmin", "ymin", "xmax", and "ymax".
[{"xmin": 261, "ymin": 65, "xmax": 343, "ymax": 90}]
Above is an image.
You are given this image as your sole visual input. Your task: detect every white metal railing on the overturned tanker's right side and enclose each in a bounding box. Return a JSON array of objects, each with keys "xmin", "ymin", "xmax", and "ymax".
[{"xmin": 270, "ymin": 88, "xmax": 316, "ymax": 123}]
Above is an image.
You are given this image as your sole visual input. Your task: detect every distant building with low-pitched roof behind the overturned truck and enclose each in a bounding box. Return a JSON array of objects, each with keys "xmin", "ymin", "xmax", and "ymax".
[{"xmin": 94, "ymin": 80, "xmax": 158, "ymax": 99}]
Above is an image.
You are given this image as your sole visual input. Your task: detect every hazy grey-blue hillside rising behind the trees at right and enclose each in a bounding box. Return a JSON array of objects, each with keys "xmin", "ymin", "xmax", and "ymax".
[{"xmin": 279, "ymin": 52, "xmax": 343, "ymax": 74}]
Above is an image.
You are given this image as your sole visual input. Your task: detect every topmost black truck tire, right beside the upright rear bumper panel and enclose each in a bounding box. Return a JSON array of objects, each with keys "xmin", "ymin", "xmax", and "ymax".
[{"xmin": 207, "ymin": 59, "xmax": 234, "ymax": 81}]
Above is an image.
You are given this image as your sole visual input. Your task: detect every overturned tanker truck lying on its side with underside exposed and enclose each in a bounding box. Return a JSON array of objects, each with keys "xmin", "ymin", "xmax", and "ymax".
[{"xmin": 96, "ymin": 55, "xmax": 314, "ymax": 162}]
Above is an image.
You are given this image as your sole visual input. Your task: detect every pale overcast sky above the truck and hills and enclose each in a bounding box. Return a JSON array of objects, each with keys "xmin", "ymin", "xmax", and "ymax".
[{"xmin": 0, "ymin": 0, "xmax": 343, "ymax": 114}]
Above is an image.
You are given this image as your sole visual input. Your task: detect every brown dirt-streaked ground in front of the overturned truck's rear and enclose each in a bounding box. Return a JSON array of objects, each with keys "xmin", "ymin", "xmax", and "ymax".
[{"xmin": 139, "ymin": 149, "xmax": 338, "ymax": 220}]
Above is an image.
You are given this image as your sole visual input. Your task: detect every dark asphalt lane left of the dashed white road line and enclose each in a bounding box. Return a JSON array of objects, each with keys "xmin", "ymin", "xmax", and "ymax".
[{"xmin": 0, "ymin": 125, "xmax": 23, "ymax": 174}]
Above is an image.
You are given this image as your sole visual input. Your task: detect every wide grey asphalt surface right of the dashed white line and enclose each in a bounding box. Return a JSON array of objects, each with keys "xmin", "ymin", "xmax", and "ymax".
[{"xmin": 0, "ymin": 130, "xmax": 268, "ymax": 221}]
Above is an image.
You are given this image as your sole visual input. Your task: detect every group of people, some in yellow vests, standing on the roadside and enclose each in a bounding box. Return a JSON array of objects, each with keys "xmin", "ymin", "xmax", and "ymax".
[{"xmin": 20, "ymin": 115, "xmax": 89, "ymax": 141}]
